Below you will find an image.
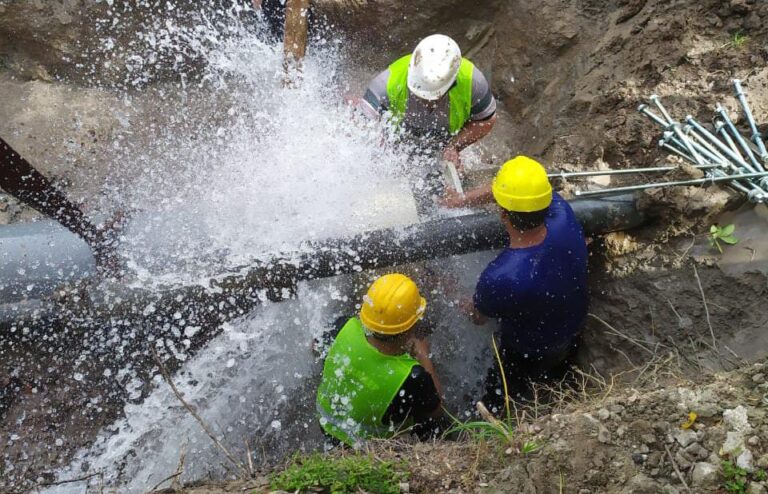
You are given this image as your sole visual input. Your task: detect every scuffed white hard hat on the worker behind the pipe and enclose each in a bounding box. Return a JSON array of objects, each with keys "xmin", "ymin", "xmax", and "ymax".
[{"xmin": 408, "ymin": 34, "xmax": 461, "ymax": 100}]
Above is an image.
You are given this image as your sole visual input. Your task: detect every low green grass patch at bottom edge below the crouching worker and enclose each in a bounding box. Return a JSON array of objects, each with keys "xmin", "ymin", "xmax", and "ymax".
[{"xmin": 270, "ymin": 454, "xmax": 408, "ymax": 494}]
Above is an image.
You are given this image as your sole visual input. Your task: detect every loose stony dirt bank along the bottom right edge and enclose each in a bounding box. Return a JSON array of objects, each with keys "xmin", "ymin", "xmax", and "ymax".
[{"xmin": 156, "ymin": 356, "xmax": 768, "ymax": 494}]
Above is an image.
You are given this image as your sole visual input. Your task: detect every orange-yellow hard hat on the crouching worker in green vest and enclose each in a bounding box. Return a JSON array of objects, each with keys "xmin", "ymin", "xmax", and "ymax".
[{"xmin": 360, "ymin": 273, "xmax": 427, "ymax": 335}]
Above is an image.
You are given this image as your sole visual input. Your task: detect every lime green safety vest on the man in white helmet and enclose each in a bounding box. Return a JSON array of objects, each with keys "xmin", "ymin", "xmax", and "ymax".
[{"xmin": 387, "ymin": 55, "xmax": 475, "ymax": 134}]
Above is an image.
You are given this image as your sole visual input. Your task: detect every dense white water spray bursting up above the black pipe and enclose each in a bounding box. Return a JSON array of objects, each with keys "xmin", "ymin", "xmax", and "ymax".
[{"xmin": 104, "ymin": 15, "xmax": 417, "ymax": 283}]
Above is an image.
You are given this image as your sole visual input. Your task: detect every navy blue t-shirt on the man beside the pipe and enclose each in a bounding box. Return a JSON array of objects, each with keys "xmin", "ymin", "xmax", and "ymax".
[{"xmin": 474, "ymin": 193, "xmax": 588, "ymax": 359}]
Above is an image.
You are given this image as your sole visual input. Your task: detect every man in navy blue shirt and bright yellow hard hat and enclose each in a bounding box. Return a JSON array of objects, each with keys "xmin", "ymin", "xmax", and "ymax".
[{"xmin": 462, "ymin": 156, "xmax": 588, "ymax": 406}]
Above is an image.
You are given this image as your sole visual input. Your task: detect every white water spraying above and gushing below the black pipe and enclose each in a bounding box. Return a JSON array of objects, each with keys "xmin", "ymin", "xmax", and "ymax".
[{"xmin": 4, "ymin": 3, "xmax": 498, "ymax": 493}]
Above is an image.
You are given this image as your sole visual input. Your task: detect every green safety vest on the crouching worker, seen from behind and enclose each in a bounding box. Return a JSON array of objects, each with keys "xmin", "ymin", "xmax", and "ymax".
[{"xmin": 317, "ymin": 317, "xmax": 418, "ymax": 446}]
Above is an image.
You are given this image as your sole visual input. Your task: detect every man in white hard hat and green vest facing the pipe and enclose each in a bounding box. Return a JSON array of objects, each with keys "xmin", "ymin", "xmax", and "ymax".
[{"xmin": 359, "ymin": 34, "xmax": 496, "ymax": 176}]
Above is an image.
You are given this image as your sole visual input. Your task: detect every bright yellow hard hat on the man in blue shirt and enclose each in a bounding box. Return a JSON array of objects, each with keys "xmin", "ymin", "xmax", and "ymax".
[{"xmin": 491, "ymin": 156, "xmax": 552, "ymax": 213}]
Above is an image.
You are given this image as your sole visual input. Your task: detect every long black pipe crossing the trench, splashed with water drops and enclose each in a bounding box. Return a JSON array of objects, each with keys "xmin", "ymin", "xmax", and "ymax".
[{"xmin": 0, "ymin": 196, "xmax": 643, "ymax": 386}]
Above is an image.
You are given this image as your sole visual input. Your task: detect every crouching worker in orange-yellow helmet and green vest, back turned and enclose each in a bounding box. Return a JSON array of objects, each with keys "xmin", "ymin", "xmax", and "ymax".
[{"xmin": 317, "ymin": 274, "xmax": 446, "ymax": 446}]
